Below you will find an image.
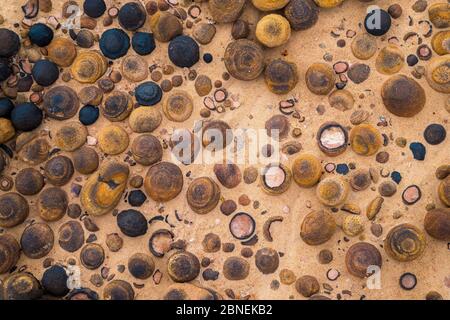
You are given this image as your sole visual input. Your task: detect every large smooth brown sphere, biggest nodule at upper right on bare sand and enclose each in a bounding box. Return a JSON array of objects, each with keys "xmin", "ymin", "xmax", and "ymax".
[{"xmin": 381, "ymin": 75, "xmax": 426, "ymax": 118}]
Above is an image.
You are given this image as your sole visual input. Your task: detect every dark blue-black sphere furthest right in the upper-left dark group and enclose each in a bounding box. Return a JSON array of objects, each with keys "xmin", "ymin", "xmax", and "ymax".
[{"xmin": 169, "ymin": 35, "xmax": 200, "ymax": 68}]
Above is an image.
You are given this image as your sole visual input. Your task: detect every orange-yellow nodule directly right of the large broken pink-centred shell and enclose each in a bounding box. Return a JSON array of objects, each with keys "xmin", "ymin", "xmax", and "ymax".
[{"xmin": 350, "ymin": 123, "xmax": 383, "ymax": 156}]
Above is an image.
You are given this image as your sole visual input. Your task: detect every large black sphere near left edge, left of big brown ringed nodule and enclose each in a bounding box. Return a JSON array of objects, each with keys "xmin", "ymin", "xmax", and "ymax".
[{"xmin": 11, "ymin": 102, "xmax": 43, "ymax": 131}]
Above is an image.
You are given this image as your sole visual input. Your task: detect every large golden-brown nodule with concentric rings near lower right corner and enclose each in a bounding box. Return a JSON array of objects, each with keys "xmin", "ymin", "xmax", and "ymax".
[{"xmin": 384, "ymin": 223, "xmax": 425, "ymax": 262}]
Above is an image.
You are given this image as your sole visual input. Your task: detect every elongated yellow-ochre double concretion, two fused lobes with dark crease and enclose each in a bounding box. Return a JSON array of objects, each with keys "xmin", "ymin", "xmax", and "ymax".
[{"xmin": 80, "ymin": 161, "xmax": 130, "ymax": 216}]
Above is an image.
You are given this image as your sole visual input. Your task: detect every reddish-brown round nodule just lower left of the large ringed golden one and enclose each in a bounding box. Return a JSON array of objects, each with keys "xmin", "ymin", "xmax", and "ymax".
[{"xmin": 345, "ymin": 242, "xmax": 383, "ymax": 278}]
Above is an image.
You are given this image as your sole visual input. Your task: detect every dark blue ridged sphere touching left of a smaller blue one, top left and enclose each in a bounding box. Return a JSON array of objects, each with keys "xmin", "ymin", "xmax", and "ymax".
[{"xmin": 100, "ymin": 28, "xmax": 130, "ymax": 59}]
